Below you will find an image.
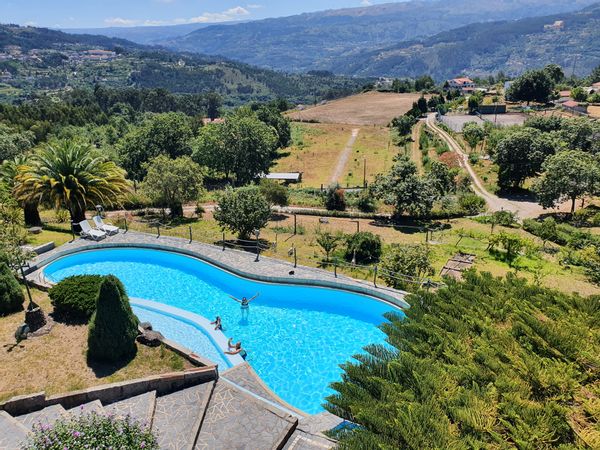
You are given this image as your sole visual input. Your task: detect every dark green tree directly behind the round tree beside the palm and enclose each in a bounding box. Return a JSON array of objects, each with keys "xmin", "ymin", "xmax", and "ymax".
[{"xmin": 118, "ymin": 113, "xmax": 193, "ymax": 181}]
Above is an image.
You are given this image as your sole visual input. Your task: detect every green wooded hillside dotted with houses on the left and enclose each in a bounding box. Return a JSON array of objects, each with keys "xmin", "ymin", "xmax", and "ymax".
[{"xmin": 0, "ymin": 25, "xmax": 367, "ymax": 105}]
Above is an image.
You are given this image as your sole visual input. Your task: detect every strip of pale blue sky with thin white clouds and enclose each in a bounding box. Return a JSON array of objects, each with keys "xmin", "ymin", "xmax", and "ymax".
[{"xmin": 0, "ymin": 0, "xmax": 393, "ymax": 28}]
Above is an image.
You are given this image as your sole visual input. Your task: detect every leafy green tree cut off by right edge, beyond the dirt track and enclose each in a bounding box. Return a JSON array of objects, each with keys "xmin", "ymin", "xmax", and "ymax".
[{"xmin": 534, "ymin": 150, "xmax": 600, "ymax": 213}]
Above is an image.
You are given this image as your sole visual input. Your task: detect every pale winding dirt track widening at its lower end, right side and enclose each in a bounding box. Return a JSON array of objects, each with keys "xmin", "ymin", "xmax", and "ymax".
[{"xmin": 427, "ymin": 114, "xmax": 562, "ymax": 219}]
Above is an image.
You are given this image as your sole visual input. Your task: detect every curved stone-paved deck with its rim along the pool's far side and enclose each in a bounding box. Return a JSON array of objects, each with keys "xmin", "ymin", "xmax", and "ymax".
[{"xmin": 27, "ymin": 231, "xmax": 409, "ymax": 308}]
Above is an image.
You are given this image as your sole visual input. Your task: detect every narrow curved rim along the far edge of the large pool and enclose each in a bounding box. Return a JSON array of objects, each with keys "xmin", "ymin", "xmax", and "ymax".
[{"xmin": 29, "ymin": 242, "xmax": 410, "ymax": 310}]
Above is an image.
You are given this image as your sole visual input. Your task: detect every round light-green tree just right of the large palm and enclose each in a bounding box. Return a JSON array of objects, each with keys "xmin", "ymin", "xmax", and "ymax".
[{"xmin": 141, "ymin": 155, "xmax": 203, "ymax": 218}]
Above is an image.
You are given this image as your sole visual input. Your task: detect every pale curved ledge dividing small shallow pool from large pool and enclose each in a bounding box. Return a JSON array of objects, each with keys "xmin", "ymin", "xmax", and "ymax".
[{"xmin": 129, "ymin": 297, "xmax": 245, "ymax": 370}]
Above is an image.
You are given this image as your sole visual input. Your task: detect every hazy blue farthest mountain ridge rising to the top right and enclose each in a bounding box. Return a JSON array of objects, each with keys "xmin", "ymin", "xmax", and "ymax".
[{"xmin": 160, "ymin": 0, "xmax": 594, "ymax": 75}]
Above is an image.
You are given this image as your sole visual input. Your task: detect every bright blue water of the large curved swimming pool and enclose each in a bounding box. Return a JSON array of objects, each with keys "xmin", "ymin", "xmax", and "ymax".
[{"xmin": 44, "ymin": 248, "xmax": 399, "ymax": 414}]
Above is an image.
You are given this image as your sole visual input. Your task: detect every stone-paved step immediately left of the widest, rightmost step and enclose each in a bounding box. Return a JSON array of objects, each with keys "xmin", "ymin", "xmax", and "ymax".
[{"xmin": 152, "ymin": 381, "xmax": 216, "ymax": 450}]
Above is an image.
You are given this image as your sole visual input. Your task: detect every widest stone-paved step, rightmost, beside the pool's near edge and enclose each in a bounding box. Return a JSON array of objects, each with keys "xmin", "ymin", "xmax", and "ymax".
[{"xmin": 195, "ymin": 379, "xmax": 298, "ymax": 450}]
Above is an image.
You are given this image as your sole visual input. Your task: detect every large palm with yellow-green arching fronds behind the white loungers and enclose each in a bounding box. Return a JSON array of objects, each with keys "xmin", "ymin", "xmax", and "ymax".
[{"xmin": 15, "ymin": 141, "xmax": 130, "ymax": 224}]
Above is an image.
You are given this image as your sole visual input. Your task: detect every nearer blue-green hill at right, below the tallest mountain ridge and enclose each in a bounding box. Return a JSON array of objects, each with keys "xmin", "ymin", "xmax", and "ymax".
[{"xmin": 334, "ymin": 3, "xmax": 600, "ymax": 79}]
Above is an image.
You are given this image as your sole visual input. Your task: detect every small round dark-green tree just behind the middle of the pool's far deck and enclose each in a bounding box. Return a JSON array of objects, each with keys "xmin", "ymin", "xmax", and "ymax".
[{"xmin": 214, "ymin": 186, "xmax": 271, "ymax": 239}]
